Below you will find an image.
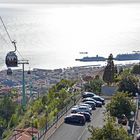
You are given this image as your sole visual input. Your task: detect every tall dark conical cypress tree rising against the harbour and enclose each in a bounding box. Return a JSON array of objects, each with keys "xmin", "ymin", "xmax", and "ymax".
[{"xmin": 103, "ymin": 54, "xmax": 115, "ymax": 85}]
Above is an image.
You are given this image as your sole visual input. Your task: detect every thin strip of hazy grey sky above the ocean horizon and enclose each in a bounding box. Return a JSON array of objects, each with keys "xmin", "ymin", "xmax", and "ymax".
[{"xmin": 0, "ymin": 0, "xmax": 140, "ymax": 3}]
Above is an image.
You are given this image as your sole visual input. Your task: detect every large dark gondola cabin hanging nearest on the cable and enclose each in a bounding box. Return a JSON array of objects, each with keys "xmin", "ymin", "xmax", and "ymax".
[{"xmin": 5, "ymin": 51, "xmax": 18, "ymax": 67}]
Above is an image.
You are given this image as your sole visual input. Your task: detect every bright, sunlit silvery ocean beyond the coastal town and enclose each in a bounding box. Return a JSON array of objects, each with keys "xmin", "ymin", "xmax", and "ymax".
[{"xmin": 0, "ymin": 3, "xmax": 140, "ymax": 69}]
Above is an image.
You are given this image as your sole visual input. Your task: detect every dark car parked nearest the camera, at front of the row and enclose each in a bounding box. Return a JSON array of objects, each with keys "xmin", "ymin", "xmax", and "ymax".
[{"xmin": 64, "ymin": 113, "xmax": 86, "ymax": 125}]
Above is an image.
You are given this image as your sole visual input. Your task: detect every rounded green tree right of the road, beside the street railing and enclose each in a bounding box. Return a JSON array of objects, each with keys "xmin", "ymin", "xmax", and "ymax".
[{"xmin": 107, "ymin": 92, "xmax": 136, "ymax": 119}]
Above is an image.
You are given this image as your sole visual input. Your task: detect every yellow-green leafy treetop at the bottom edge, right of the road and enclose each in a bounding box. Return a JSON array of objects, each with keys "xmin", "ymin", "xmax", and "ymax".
[{"xmin": 88, "ymin": 117, "xmax": 132, "ymax": 140}]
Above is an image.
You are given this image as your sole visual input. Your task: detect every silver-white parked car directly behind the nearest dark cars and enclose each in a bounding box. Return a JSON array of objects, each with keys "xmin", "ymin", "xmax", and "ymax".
[{"xmin": 71, "ymin": 106, "xmax": 91, "ymax": 114}]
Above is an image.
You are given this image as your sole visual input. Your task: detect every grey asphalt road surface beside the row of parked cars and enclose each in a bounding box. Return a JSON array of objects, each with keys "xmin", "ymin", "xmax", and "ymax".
[{"xmin": 49, "ymin": 106, "xmax": 105, "ymax": 140}]
